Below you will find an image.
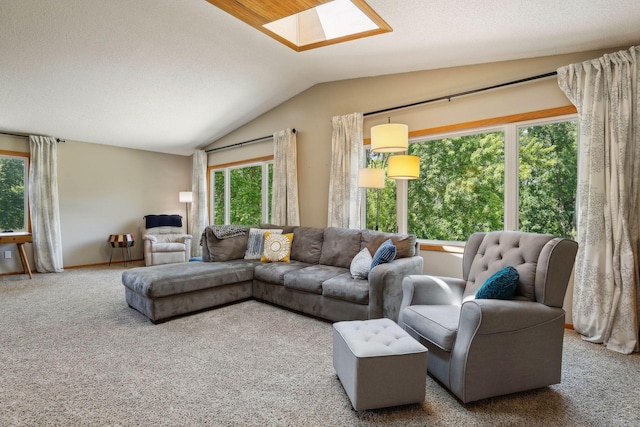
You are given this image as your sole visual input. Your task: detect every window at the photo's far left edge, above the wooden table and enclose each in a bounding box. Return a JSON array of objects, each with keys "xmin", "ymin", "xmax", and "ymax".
[{"xmin": 0, "ymin": 153, "xmax": 29, "ymax": 231}]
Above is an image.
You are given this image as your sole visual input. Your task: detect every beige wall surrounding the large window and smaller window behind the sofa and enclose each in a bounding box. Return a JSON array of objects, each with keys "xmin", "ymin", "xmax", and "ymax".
[{"xmin": 208, "ymin": 48, "xmax": 622, "ymax": 319}]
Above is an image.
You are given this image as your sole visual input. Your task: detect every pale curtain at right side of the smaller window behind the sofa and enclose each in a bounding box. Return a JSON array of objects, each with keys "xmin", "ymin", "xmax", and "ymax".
[{"xmin": 271, "ymin": 129, "xmax": 300, "ymax": 225}]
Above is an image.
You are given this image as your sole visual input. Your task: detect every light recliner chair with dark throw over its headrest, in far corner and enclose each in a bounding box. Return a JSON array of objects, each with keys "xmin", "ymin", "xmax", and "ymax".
[{"xmin": 142, "ymin": 215, "xmax": 191, "ymax": 266}]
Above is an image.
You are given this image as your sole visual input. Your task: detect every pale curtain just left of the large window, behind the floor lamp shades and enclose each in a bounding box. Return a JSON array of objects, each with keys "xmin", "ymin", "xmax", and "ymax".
[{"xmin": 327, "ymin": 113, "xmax": 364, "ymax": 228}]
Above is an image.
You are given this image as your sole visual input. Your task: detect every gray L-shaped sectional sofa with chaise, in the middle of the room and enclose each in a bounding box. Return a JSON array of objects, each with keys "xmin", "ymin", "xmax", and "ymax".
[{"xmin": 122, "ymin": 225, "xmax": 423, "ymax": 323}]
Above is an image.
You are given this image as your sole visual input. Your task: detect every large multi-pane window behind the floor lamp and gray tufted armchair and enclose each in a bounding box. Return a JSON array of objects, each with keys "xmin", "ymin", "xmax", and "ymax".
[{"xmin": 366, "ymin": 115, "xmax": 577, "ymax": 241}]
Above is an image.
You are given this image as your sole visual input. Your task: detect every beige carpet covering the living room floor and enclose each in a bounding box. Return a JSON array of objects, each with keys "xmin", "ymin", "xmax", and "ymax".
[{"xmin": 0, "ymin": 265, "xmax": 640, "ymax": 426}]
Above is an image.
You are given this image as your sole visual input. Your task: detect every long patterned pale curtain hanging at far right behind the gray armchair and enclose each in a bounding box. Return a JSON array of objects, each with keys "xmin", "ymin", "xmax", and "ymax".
[{"xmin": 558, "ymin": 47, "xmax": 640, "ymax": 353}]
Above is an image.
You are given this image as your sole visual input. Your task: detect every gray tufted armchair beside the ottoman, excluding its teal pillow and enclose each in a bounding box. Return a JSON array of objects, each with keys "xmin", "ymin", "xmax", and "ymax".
[{"xmin": 398, "ymin": 231, "xmax": 578, "ymax": 403}]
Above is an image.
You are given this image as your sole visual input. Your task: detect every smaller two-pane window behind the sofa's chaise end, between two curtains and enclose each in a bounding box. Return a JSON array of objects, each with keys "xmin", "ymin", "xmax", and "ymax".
[{"xmin": 209, "ymin": 161, "xmax": 273, "ymax": 226}]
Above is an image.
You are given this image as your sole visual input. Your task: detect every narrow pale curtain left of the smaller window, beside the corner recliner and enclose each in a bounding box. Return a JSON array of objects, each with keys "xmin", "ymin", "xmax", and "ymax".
[{"xmin": 189, "ymin": 150, "xmax": 209, "ymax": 257}]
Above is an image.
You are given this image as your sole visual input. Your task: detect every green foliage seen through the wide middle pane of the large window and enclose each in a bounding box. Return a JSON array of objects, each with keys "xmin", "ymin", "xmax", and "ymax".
[{"xmin": 407, "ymin": 131, "xmax": 504, "ymax": 241}]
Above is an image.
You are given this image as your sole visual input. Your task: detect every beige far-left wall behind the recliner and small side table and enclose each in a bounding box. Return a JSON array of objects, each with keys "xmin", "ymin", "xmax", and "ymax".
[{"xmin": 0, "ymin": 135, "xmax": 191, "ymax": 274}]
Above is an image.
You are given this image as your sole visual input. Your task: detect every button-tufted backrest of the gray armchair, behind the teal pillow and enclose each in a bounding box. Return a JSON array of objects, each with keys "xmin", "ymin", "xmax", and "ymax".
[{"xmin": 462, "ymin": 231, "xmax": 578, "ymax": 307}]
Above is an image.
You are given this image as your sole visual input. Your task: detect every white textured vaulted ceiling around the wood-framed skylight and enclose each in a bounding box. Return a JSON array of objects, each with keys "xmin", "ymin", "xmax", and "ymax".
[{"xmin": 0, "ymin": 0, "xmax": 640, "ymax": 155}]
